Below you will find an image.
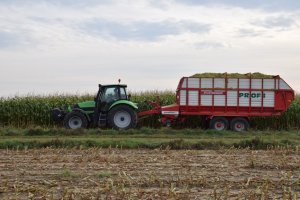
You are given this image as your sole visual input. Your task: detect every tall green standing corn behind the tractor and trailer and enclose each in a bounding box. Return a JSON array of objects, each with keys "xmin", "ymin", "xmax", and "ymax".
[{"xmin": 0, "ymin": 91, "xmax": 300, "ymax": 130}]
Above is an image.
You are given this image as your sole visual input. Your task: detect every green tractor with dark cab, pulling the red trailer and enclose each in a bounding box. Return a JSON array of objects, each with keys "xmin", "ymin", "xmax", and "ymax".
[{"xmin": 52, "ymin": 84, "xmax": 138, "ymax": 130}]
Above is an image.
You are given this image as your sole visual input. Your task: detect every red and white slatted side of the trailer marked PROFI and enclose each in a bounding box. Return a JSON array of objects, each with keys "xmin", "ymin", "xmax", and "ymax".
[{"xmin": 177, "ymin": 76, "xmax": 294, "ymax": 116}]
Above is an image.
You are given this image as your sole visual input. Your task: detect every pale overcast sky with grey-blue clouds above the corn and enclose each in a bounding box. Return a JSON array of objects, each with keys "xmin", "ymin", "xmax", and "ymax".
[{"xmin": 0, "ymin": 0, "xmax": 300, "ymax": 96}]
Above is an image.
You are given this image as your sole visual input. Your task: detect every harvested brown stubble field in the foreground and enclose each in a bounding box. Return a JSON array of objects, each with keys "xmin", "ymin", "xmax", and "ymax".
[{"xmin": 0, "ymin": 147, "xmax": 300, "ymax": 199}]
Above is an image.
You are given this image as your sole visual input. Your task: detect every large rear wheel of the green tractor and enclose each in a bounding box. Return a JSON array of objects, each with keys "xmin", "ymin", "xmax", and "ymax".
[{"xmin": 108, "ymin": 105, "xmax": 137, "ymax": 130}]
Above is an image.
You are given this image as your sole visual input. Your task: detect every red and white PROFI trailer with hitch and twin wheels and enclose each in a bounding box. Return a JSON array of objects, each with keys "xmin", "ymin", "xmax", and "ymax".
[{"xmin": 139, "ymin": 76, "xmax": 295, "ymax": 130}]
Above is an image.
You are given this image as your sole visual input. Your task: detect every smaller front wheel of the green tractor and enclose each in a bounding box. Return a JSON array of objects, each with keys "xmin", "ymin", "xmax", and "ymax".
[{"xmin": 63, "ymin": 111, "xmax": 88, "ymax": 129}]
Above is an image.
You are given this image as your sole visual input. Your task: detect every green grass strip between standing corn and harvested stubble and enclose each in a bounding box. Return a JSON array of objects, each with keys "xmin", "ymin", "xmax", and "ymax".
[{"xmin": 0, "ymin": 128, "xmax": 300, "ymax": 149}]
